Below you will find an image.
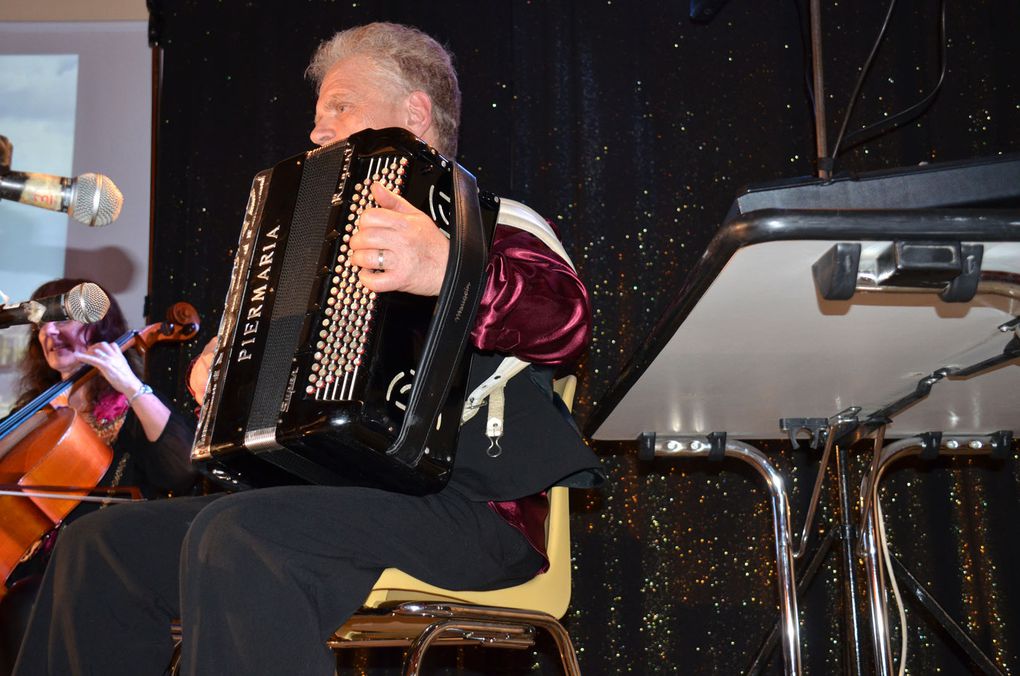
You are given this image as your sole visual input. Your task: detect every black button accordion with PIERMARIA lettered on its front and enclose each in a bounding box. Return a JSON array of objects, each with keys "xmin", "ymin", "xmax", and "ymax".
[{"xmin": 192, "ymin": 128, "xmax": 498, "ymax": 495}]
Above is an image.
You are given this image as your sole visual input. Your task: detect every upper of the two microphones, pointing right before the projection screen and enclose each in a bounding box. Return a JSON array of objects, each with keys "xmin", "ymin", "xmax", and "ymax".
[{"xmin": 0, "ymin": 171, "xmax": 124, "ymax": 226}]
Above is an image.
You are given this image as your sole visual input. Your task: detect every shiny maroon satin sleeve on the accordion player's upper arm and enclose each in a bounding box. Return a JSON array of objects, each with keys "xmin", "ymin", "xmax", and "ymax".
[{"xmin": 471, "ymin": 225, "xmax": 592, "ymax": 365}]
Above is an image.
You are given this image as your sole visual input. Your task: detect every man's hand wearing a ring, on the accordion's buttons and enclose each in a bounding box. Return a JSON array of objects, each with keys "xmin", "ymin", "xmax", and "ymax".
[{"xmin": 351, "ymin": 183, "xmax": 450, "ymax": 296}]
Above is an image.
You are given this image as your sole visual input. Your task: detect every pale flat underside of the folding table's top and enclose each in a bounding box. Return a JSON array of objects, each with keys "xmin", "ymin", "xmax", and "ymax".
[{"xmin": 589, "ymin": 210, "xmax": 1020, "ymax": 439}]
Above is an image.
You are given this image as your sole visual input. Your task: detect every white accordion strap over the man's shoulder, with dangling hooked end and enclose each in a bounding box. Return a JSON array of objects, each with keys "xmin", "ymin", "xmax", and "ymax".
[{"xmin": 460, "ymin": 198, "xmax": 576, "ymax": 457}]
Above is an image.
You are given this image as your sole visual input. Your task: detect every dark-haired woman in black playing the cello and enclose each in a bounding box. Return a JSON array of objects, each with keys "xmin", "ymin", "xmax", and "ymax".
[{"xmin": 0, "ymin": 278, "xmax": 195, "ymax": 675}]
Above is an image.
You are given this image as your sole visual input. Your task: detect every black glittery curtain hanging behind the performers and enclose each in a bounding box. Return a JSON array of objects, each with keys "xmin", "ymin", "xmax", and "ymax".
[{"xmin": 150, "ymin": 0, "xmax": 1020, "ymax": 674}]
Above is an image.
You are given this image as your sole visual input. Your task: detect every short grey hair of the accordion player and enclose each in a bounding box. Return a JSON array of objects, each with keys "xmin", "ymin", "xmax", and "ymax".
[{"xmin": 305, "ymin": 22, "xmax": 460, "ymax": 159}]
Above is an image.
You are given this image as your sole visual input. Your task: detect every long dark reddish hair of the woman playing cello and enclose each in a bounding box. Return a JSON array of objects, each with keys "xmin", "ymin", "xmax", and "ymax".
[{"xmin": 15, "ymin": 277, "xmax": 139, "ymax": 408}]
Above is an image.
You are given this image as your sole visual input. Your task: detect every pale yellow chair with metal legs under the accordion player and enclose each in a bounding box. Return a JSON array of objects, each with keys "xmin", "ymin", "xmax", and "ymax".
[{"xmin": 326, "ymin": 376, "xmax": 580, "ymax": 676}]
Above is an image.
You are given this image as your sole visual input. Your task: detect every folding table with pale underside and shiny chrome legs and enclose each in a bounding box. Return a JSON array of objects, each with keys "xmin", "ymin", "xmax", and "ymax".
[{"xmin": 585, "ymin": 204, "xmax": 1020, "ymax": 673}]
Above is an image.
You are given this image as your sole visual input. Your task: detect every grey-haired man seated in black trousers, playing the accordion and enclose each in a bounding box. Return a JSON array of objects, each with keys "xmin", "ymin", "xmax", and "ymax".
[{"xmin": 16, "ymin": 23, "xmax": 600, "ymax": 676}]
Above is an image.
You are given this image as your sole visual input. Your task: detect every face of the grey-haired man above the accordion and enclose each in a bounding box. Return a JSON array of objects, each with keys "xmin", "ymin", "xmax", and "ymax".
[{"xmin": 310, "ymin": 55, "xmax": 408, "ymax": 146}]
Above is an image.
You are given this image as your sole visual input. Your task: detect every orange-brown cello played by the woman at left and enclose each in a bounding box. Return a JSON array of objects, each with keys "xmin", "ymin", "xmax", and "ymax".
[{"xmin": 0, "ymin": 303, "xmax": 199, "ymax": 597}]
